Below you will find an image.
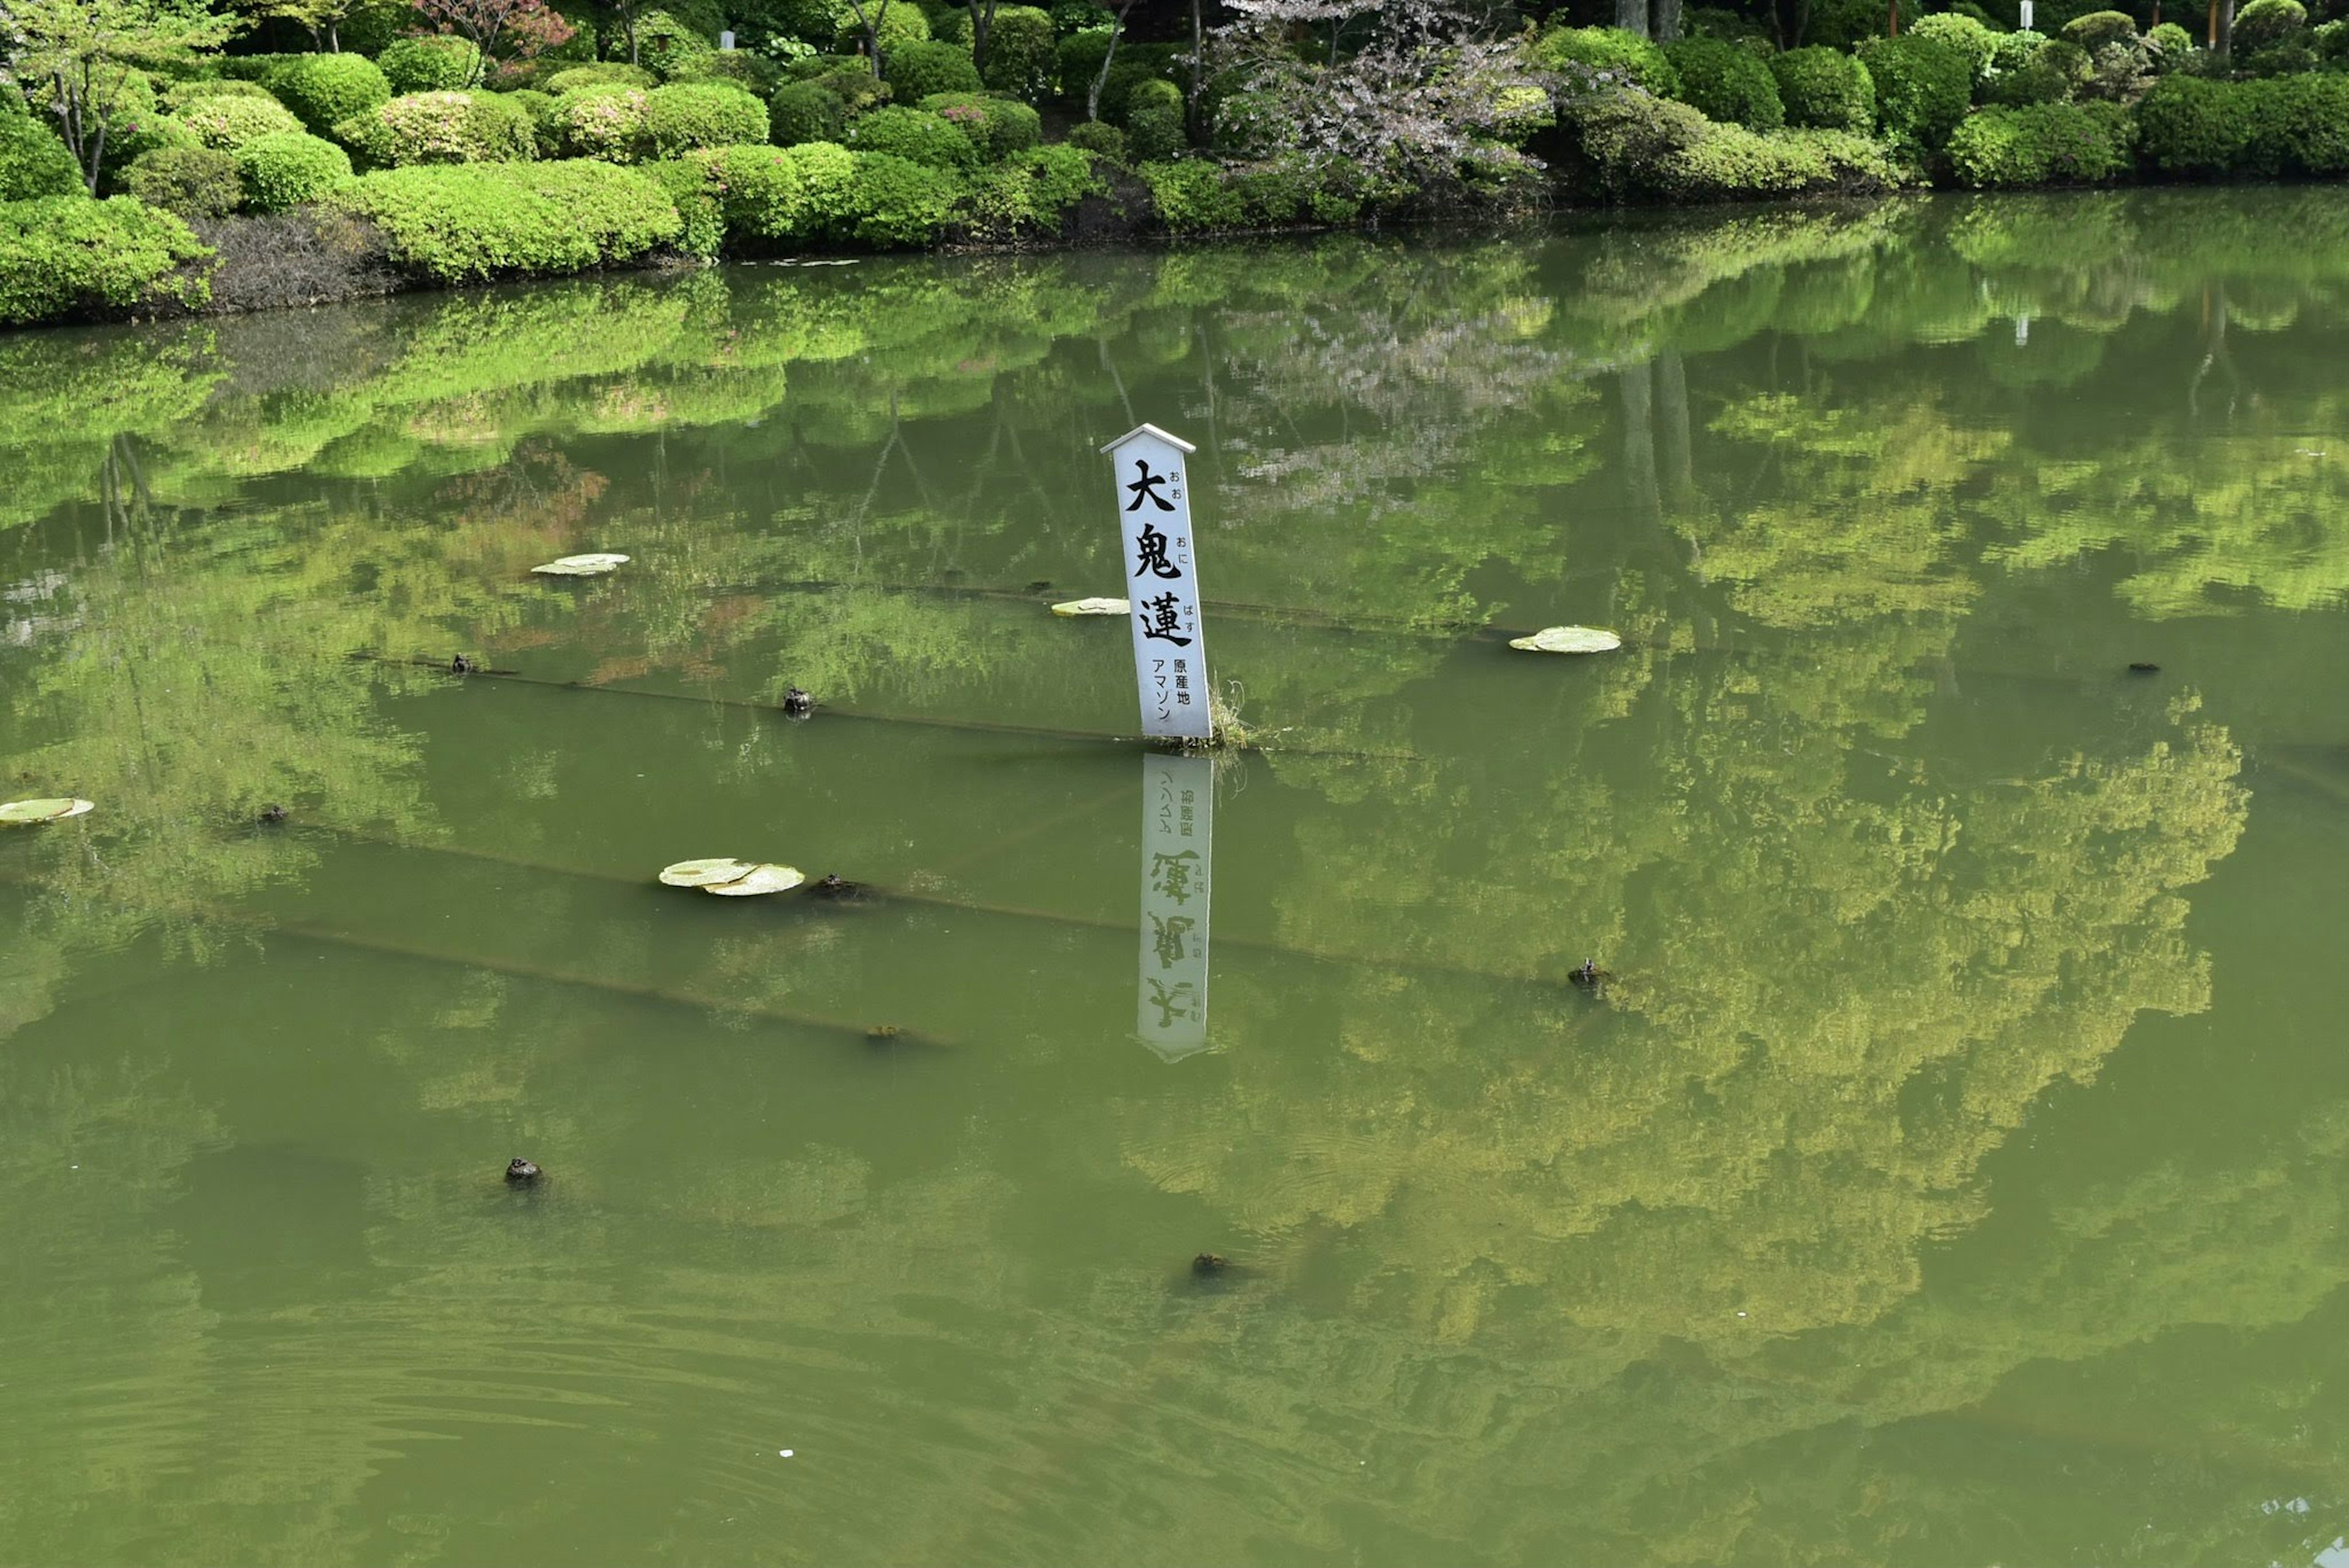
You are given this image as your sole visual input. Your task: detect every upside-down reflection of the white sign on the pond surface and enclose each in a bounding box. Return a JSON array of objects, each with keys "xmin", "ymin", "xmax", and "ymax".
[{"xmin": 1135, "ymin": 757, "xmax": 1214, "ymax": 1063}]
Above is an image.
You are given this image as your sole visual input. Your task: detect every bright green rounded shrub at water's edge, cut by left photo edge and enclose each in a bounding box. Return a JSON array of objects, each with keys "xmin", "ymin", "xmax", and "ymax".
[{"xmin": 0, "ymin": 195, "xmax": 212, "ymax": 327}]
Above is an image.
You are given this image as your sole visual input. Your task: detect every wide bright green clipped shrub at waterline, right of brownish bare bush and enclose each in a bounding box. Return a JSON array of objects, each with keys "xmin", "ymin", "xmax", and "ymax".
[{"xmin": 329, "ymin": 160, "xmax": 683, "ymax": 282}]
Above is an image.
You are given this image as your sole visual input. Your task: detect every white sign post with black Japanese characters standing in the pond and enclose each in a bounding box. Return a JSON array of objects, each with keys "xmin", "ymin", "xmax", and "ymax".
[{"xmin": 1102, "ymin": 426, "xmax": 1208, "ymax": 740}]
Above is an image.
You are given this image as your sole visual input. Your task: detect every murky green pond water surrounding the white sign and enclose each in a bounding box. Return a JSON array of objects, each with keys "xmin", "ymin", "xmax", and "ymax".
[{"xmin": 0, "ymin": 188, "xmax": 2349, "ymax": 1566}]
